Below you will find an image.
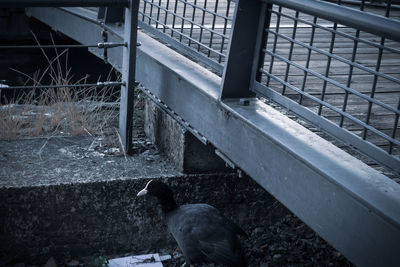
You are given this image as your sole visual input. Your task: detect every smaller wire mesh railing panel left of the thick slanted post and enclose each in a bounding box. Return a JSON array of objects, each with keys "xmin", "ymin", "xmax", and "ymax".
[{"xmin": 139, "ymin": 0, "xmax": 235, "ymax": 74}]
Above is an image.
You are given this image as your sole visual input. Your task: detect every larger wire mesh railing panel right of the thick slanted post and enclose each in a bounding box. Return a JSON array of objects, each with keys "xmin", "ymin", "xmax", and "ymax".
[{"xmin": 253, "ymin": 1, "xmax": 400, "ymax": 172}]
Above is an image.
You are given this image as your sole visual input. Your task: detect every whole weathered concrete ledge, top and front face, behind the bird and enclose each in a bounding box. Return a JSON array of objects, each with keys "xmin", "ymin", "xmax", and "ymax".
[{"xmin": 0, "ymin": 137, "xmax": 286, "ymax": 262}]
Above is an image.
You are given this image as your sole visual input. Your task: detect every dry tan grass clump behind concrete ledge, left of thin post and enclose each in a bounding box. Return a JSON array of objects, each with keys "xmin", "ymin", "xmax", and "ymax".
[{"xmin": 0, "ymin": 34, "xmax": 119, "ymax": 140}]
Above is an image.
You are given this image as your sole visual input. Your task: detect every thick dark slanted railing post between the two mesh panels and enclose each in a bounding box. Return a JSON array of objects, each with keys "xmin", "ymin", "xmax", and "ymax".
[{"xmin": 220, "ymin": 0, "xmax": 267, "ymax": 99}]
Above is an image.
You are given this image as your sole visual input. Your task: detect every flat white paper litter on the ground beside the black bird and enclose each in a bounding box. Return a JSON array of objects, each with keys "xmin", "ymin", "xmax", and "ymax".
[{"xmin": 108, "ymin": 254, "xmax": 163, "ymax": 267}]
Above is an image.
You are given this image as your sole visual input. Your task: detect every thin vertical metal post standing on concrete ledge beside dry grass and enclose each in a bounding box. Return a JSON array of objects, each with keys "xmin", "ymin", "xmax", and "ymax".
[{"xmin": 119, "ymin": 0, "xmax": 139, "ymax": 153}]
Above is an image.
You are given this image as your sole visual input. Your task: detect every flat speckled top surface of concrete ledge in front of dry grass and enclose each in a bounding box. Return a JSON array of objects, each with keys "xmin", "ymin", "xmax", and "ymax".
[{"xmin": 0, "ymin": 137, "xmax": 180, "ymax": 187}]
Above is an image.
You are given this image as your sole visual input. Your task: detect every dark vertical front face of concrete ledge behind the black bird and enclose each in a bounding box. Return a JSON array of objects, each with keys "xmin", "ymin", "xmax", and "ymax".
[{"xmin": 0, "ymin": 174, "xmax": 286, "ymax": 263}]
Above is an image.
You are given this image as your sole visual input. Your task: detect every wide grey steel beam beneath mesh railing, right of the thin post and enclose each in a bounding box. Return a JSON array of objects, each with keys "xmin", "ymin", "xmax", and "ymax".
[{"xmin": 27, "ymin": 6, "xmax": 400, "ymax": 266}]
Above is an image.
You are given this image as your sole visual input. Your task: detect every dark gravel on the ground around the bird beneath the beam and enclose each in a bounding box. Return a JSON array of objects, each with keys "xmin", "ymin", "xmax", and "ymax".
[{"xmin": 159, "ymin": 214, "xmax": 353, "ymax": 267}]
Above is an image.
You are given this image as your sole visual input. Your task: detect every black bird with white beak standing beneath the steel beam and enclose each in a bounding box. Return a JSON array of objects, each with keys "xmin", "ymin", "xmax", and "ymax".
[{"xmin": 137, "ymin": 180, "xmax": 247, "ymax": 267}]
